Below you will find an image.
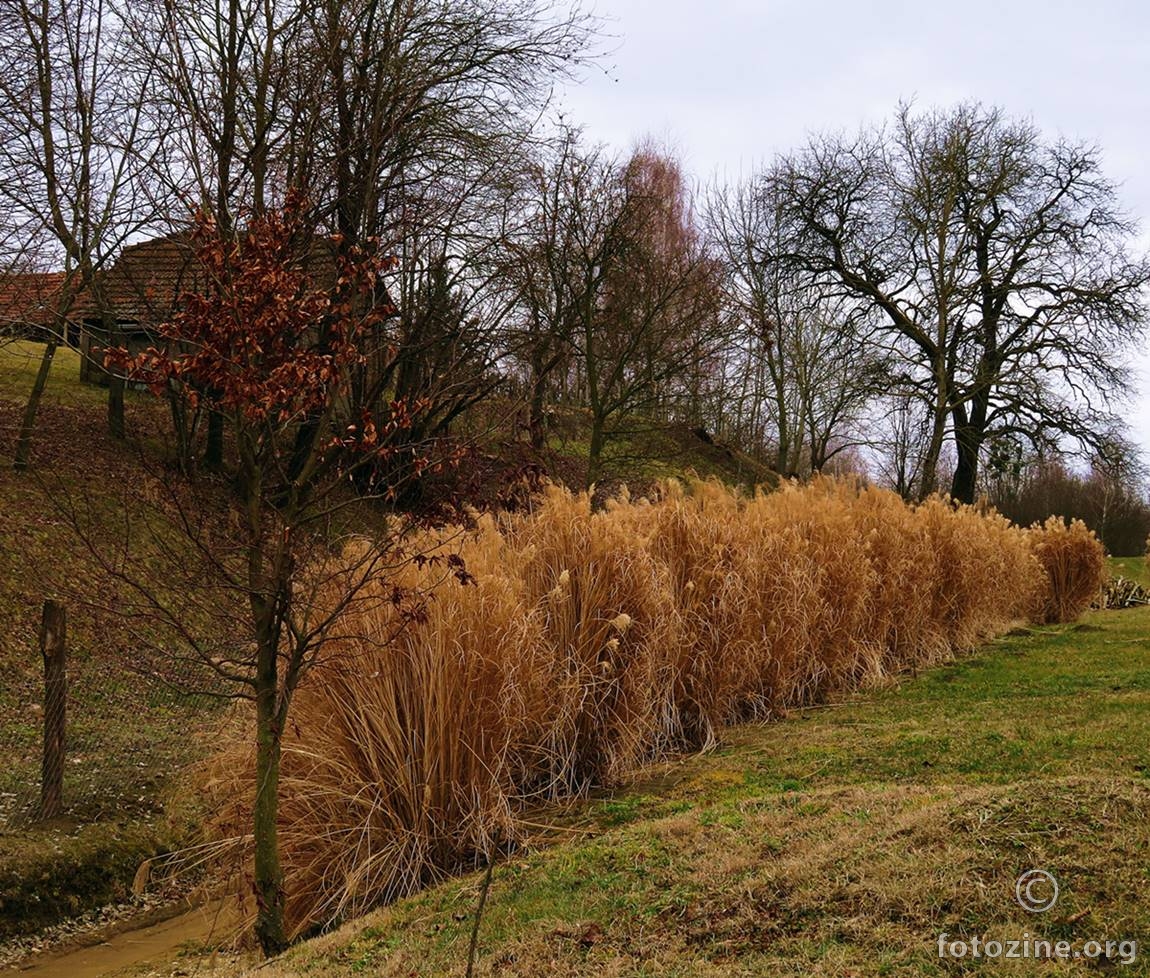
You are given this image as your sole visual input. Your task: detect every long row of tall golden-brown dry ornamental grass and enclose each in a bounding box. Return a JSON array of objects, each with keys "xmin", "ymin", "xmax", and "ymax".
[{"xmin": 204, "ymin": 480, "xmax": 1095, "ymax": 935}]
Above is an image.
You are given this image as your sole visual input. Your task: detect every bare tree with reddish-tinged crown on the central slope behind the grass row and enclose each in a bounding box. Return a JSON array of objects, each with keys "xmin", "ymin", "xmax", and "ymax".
[{"xmin": 520, "ymin": 139, "xmax": 719, "ymax": 484}]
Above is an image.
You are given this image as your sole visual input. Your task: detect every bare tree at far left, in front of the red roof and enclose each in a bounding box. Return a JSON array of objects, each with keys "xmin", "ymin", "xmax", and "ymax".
[{"xmin": 0, "ymin": 0, "xmax": 161, "ymax": 453}]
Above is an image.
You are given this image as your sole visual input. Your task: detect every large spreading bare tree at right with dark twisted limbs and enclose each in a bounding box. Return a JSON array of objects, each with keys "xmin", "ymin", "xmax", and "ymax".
[{"xmin": 767, "ymin": 105, "xmax": 1150, "ymax": 501}]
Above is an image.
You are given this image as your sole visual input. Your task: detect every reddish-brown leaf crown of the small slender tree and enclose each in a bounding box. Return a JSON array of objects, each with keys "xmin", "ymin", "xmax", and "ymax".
[{"xmin": 107, "ymin": 200, "xmax": 394, "ymax": 423}]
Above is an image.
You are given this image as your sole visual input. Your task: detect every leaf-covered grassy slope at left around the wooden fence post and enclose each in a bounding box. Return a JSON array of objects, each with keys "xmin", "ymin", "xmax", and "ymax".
[{"xmin": 0, "ymin": 343, "xmax": 220, "ymax": 810}]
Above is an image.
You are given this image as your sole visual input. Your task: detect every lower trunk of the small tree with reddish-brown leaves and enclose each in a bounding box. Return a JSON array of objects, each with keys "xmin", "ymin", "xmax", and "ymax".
[{"xmin": 252, "ymin": 642, "xmax": 288, "ymax": 957}]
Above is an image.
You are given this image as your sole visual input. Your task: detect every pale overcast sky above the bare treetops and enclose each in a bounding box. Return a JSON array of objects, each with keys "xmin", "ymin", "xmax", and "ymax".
[{"xmin": 561, "ymin": 0, "xmax": 1150, "ymax": 454}]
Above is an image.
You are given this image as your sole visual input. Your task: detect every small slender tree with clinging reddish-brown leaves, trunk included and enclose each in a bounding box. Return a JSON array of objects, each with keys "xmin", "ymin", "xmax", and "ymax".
[{"xmin": 109, "ymin": 197, "xmax": 455, "ymax": 954}]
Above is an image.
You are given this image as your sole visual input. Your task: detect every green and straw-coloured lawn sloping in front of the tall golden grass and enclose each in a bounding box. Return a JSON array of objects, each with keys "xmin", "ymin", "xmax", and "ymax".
[{"xmin": 172, "ymin": 567, "xmax": 1150, "ymax": 978}]
